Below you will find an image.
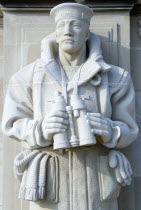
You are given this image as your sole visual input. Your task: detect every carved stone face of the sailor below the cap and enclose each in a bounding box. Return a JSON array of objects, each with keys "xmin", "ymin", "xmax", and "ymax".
[{"xmin": 56, "ymin": 19, "xmax": 89, "ymax": 54}]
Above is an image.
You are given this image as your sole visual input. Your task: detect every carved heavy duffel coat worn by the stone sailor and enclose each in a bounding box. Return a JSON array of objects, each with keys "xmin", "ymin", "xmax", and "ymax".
[{"xmin": 2, "ymin": 34, "xmax": 138, "ymax": 210}]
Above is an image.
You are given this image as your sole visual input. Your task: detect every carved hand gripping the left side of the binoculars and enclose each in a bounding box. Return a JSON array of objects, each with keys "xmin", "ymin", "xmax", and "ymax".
[{"xmin": 42, "ymin": 111, "xmax": 68, "ymax": 140}]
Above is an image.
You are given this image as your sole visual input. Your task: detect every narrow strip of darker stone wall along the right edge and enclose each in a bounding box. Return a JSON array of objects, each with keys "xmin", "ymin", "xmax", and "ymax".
[{"xmin": 130, "ymin": 6, "xmax": 141, "ymax": 210}]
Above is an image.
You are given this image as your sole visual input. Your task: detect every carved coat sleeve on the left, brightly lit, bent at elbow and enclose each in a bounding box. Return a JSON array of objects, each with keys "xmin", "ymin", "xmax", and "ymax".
[{"xmin": 2, "ymin": 73, "xmax": 52, "ymax": 148}]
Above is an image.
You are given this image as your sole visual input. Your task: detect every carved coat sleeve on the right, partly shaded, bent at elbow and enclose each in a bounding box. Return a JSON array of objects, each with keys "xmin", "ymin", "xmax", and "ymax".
[{"xmin": 103, "ymin": 72, "xmax": 138, "ymax": 149}]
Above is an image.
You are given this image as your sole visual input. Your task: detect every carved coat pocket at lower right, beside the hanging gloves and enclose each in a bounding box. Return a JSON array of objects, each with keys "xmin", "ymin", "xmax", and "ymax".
[{"xmin": 98, "ymin": 155, "xmax": 121, "ymax": 201}]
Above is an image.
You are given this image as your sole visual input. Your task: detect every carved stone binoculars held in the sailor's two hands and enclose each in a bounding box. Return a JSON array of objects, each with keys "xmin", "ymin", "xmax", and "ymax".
[{"xmin": 52, "ymin": 92, "xmax": 96, "ymax": 149}]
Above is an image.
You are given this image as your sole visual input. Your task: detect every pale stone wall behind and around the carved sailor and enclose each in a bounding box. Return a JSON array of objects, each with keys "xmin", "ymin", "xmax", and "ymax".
[{"xmin": 0, "ymin": 1, "xmax": 141, "ymax": 210}]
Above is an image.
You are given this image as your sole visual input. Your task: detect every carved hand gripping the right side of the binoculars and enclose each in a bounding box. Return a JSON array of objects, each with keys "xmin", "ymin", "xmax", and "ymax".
[{"xmin": 86, "ymin": 113, "xmax": 113, "ymax": 143}]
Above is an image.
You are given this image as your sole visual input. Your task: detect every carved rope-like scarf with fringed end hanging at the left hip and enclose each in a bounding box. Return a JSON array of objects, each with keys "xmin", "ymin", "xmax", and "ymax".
[{"xmin": 14, "ymin": 150, "xmax": 58, "ymax": 202}]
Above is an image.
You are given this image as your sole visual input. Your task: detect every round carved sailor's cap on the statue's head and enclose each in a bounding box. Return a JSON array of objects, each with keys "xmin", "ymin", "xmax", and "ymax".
[{"xmin": 50, "ymin": 3, "xmax": 94, "ymax": 23}]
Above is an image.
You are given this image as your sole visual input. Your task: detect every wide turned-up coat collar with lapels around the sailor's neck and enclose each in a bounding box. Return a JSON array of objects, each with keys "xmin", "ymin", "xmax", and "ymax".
[{"xmin": 39, "ymin": 33, "xmax": 111, "ymax": 91}]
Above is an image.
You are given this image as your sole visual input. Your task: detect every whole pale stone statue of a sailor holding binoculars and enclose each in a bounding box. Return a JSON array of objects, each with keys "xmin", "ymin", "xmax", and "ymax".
[{"xmin": 2, "ymin": 3, "xmax": 138, "ymax": 210}]
